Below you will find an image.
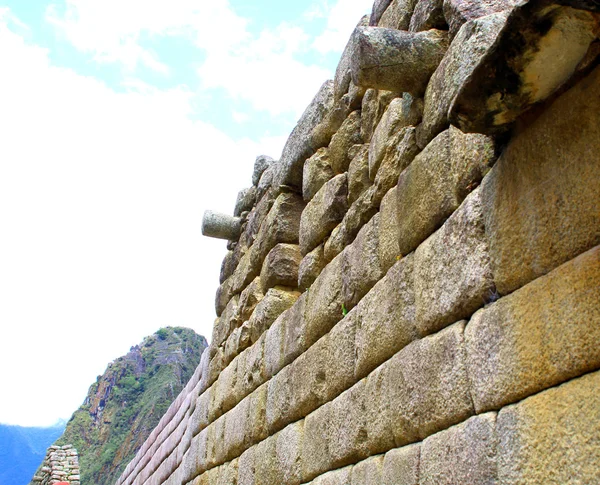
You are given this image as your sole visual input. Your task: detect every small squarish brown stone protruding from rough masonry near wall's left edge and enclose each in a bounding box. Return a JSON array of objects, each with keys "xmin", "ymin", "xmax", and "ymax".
[{"xmin": 260, "ymin": 244, "xmax": 302, "ymax": 290}]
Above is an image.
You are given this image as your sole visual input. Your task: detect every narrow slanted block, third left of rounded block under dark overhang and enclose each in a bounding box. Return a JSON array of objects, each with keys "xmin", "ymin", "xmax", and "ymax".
[{"xmin": 303, "ymin": 251, "xmax": 344, "ymax": 347}]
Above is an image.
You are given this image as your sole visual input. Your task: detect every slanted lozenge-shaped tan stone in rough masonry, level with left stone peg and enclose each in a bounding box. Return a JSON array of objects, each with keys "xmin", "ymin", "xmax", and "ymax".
[{"xmin": 300, "ymin": 174, "xmax": 348, "ymax": 255}]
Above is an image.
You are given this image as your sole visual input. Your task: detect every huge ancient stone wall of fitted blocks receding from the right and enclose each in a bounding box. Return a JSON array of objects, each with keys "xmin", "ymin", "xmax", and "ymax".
[{"xmin": 117, "ymin": 0, "xmax": 600, "ymax": 485}]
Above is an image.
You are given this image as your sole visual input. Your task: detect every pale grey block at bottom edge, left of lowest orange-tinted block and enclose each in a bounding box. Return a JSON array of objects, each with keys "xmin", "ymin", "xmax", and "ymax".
[{"xmin": 419, "ymin": 413, "xmax": 500, "ymax": 485}]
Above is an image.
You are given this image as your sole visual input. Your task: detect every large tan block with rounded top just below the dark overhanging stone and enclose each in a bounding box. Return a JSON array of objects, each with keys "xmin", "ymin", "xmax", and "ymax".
[{"xmin": 397, "ymin": 127, "xmax": 496, "ymax": 254}]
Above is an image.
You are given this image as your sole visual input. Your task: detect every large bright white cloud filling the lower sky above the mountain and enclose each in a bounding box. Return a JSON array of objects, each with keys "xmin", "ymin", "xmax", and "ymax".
[{"xmin": 0, "ymin": 16, "xmax": 283, "ymax": 424}]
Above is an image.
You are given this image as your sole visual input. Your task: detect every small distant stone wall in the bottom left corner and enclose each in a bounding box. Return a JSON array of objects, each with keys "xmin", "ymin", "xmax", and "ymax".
[{"xmin": 31, "ymin": 445, "xmax": 80, "ymax": 485}]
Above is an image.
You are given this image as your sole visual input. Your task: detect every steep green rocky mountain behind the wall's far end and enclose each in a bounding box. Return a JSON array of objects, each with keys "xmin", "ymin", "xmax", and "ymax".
[{"xmin": 44, "ymin": 327, "xmax": 207, "ymax": 485}]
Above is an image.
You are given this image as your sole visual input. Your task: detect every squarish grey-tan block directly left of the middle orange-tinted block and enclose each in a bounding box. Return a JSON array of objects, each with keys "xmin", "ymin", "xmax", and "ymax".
[{"xmin": 386, "ymin": 322, "xmax": 474, "ymax": 446}]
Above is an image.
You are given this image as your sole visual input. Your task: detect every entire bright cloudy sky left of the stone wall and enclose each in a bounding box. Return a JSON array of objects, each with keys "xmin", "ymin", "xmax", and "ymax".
[{"xmin": 0, "ymin": 0, "xmax": 372, "ymax": 426}]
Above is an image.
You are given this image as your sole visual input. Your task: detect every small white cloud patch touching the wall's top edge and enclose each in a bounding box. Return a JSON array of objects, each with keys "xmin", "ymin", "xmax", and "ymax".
[{"xmin": 312, "ymin": 0, "xmax": 373, "ymax": 54}]
